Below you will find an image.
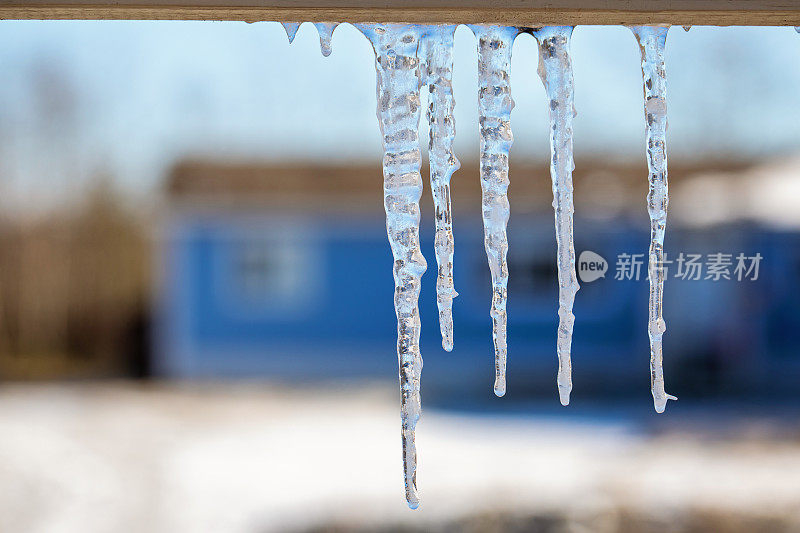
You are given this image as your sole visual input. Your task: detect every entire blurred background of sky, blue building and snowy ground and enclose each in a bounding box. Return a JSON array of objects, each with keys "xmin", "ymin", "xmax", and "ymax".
[{"xmin": 0, "ymin": 21, "xmax": 800, "ymax": 532}]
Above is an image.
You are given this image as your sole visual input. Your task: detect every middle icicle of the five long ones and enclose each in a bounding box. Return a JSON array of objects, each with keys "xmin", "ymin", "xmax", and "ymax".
[{"xmin": 471, "ymin": 25, "xmax": 519, "ymax": 396}]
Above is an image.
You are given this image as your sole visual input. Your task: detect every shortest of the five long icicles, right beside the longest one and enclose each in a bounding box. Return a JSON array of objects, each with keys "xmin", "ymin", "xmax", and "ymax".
[{"xmin": 420, "ymin": 26, "xmax": 461, "ymax": 352}]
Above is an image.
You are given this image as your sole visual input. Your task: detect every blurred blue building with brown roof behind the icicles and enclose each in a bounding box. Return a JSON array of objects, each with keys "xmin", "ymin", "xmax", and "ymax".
[{"xmin": 155, "ymin": 158, "xmax": 800, "ymax": 395}]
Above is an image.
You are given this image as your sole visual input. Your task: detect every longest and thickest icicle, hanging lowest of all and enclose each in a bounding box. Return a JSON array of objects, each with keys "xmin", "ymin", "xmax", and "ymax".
[{"xmin": 358, "ymin": 24, "xmax": 427, "ymax": 509}]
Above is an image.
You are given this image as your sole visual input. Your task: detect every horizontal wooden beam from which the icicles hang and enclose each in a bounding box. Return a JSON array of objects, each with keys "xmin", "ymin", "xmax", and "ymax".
[{"xmin": 0, "ymin": 0, "xmax": 800, "ymax": 26}]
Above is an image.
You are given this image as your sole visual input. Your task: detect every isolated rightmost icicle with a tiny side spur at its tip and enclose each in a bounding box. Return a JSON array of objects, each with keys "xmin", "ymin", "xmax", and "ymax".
[{"xmin": 631, "ymin": 26, "xmax": 677, "ymax": 413}]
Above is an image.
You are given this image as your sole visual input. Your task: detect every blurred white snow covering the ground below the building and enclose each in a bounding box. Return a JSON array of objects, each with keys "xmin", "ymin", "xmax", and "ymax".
[{"xmin": 0, "ymin": 383, "xmax": 800, "ymax": 533}]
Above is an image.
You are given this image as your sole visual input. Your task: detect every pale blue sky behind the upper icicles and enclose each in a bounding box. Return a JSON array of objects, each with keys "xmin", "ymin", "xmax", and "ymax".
[{"xmin": 0, "ymin": 21, "xmax": 800, "ymax": 205}]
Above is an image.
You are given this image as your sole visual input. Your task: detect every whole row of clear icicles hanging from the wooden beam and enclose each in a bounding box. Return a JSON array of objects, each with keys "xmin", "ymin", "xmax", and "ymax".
[{"xmin": 283, "ymin": 23, "xmax": 675, "ymax": 508}]
